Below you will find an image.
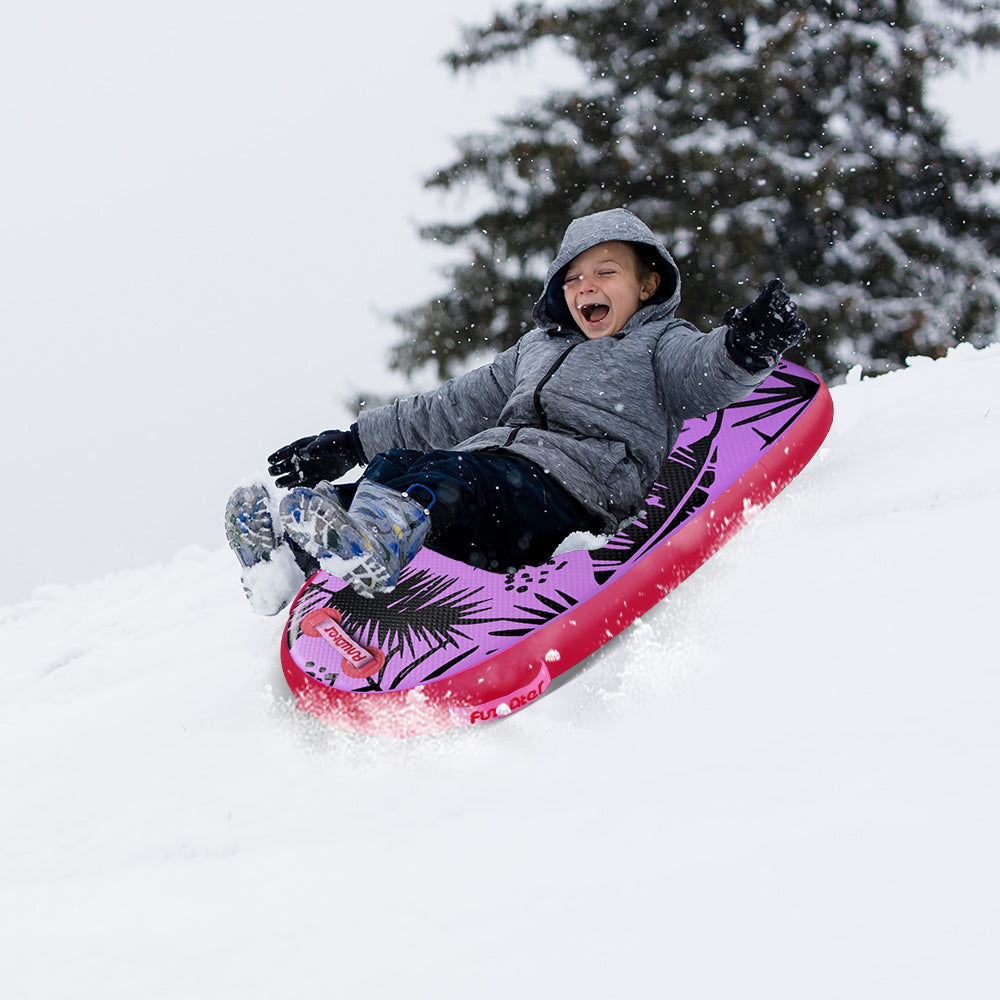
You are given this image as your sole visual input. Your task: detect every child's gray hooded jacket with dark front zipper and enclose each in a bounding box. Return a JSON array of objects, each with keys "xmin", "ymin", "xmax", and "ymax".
[{"xmin": 358, "ymin": 209, "xmax": 770, "ymax": 531}]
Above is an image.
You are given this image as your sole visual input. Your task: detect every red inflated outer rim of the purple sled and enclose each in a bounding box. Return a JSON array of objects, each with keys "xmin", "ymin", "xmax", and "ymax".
[{"xmin": 281, "ymin": 382, "xmax": 833, "ymax": 736}]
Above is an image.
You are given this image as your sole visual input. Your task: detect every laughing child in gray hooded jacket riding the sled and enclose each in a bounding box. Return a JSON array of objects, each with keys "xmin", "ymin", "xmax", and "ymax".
[{"xmin": 226, "ymin": 209, "xmax": 806, "ymax": 614}]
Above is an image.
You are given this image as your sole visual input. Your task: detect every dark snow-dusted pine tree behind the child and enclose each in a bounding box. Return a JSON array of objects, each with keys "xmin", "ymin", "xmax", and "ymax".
[{"xmin": 392, "ymin": 0, "xmax": 1000, "ymax": 377}]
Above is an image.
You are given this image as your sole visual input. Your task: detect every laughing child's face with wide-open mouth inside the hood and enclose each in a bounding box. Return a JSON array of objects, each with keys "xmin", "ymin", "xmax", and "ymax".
[{"xmin": 563, "ymin": 240, "xmax": 660, "ymax": 340}]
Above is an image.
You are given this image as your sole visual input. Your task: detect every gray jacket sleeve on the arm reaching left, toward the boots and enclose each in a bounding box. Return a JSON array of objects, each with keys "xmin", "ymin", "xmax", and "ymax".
[{"xmin": 358, "ymin": 344, "xmax": 518, "ymax": 461}]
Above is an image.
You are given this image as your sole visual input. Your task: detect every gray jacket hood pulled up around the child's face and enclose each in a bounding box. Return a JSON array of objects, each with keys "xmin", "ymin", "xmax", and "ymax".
[{"xmin": 531, "ymin": 208, "xmax": 681, "ymax": 330}]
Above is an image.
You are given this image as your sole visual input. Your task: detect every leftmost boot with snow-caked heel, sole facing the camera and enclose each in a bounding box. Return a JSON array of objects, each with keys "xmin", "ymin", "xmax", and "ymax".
[{"xmin": 226, "ymin": 483, "xmax": 305, "ymax": 615}]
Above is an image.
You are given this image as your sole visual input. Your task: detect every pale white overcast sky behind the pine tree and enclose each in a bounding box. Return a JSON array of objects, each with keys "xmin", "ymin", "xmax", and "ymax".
[{"xmin": 0, "ymin": 0, "xmax": 1000, "ymax": 603}]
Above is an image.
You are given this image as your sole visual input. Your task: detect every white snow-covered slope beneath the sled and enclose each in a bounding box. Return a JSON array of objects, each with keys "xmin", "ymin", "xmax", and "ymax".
[{"xmin": 0, "ymin": 347, "xmax": 1000, "ymax": 1000}]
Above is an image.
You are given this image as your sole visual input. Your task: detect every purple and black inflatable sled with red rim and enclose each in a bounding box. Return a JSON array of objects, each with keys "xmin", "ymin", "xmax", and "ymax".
[{"xmin": 281, "ymin": 363, "xmax": 833, "ymax": 736}]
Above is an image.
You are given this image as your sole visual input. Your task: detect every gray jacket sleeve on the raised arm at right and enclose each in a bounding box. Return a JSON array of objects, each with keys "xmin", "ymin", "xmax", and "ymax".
[{"xmin": 655, "ymin": 320, "xmax": 772, "ymax": 420}]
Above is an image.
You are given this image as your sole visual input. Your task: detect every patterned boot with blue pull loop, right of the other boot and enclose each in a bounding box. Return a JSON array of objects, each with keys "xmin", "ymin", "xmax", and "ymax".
[{"xmin": 280, "ymin": 479, "xmax": 431, "ymax": 596}]
